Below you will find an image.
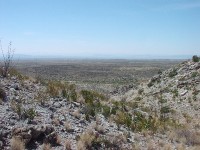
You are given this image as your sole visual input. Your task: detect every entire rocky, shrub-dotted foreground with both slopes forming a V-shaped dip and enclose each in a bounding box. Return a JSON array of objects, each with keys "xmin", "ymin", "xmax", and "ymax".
[{"xmin": 0, "ymin": 61, "xmax": 200, "ymax": 150}]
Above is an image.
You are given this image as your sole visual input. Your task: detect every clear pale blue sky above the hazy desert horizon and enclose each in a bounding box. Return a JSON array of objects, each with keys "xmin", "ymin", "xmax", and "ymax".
[{"xmin": 0, "ymin": 0, "xmax": 200, "ymax": 58}]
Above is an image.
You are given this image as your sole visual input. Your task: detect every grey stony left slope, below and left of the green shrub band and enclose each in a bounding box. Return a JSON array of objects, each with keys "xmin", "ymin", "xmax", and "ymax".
[{"xmin": 0, "ymin": 77, "xmax": 134, "ymax": 150}]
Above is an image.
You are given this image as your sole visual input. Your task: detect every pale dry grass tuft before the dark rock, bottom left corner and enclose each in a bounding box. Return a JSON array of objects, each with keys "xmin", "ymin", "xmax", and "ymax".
[{"xmin": 11, "ymin": 137, "xmax": 25, "ymax": 150}]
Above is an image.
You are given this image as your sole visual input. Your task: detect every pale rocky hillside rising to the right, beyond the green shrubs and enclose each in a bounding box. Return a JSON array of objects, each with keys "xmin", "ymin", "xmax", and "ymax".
[{"xmin": 112, "ymin": 60, "xmax": 200, "ymax": 149}]
